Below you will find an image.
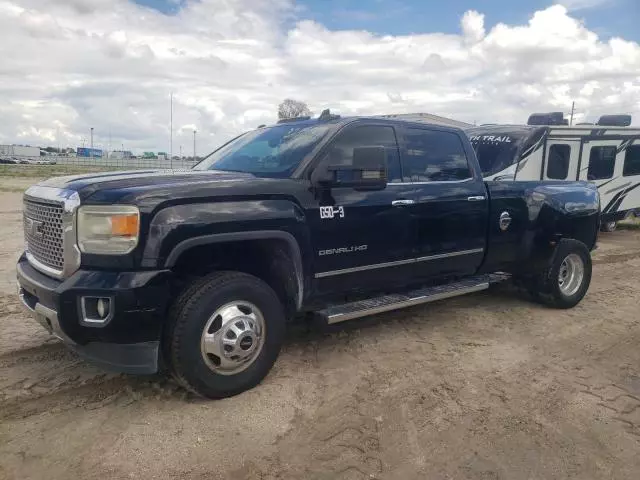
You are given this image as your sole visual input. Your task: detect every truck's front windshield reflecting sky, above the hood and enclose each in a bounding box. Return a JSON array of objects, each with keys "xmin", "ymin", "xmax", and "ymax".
[{"xmin": 193, "ymin": 123, "xmax": 331, "ymax": 178}]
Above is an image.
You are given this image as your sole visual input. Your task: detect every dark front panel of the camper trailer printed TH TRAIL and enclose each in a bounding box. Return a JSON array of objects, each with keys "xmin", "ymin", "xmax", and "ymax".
[{"xmin": 466, "ymin": 130, "xmax": 530, "ymax": 178}]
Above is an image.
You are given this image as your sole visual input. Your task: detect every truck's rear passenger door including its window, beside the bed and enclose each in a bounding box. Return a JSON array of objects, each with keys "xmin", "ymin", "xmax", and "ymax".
[{"xmin": 400, "ymin": 126, "xmax": 489, "ymax": 279}]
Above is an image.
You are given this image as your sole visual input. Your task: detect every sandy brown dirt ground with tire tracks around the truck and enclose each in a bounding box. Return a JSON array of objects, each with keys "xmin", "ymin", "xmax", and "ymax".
[{"xmin": 0, "ymin": 181, "xmax": 640, "ymax": 480}]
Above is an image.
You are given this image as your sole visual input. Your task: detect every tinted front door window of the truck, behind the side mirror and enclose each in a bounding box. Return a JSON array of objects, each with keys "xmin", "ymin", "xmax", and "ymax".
[{"xmin": 322, "ymin": 125, "xmax": 402, "ymax": 183}]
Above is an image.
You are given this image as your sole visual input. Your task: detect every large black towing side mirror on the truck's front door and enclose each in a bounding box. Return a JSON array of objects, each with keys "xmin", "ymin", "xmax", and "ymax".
[{"xmin": 323, "ymin": 146, "xmax": 387, "ymax": 189}]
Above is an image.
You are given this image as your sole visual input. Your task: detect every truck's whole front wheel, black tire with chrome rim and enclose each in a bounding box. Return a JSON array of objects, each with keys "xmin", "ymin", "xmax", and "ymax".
[{"xmin": 164, "ymin": 272, "xmax": 286, "ymax": 398}]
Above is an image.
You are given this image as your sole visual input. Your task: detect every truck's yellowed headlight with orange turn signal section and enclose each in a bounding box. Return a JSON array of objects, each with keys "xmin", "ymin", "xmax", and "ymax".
[{"xmin": 78, "ymin": 205, "xmax": 140, "ymax": 255}]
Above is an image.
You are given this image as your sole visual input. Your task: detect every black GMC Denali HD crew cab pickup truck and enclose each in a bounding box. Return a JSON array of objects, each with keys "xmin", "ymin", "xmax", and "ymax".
[{"xmin": 17, "ymin": 112, "xmax": 600, "ymax": 398}]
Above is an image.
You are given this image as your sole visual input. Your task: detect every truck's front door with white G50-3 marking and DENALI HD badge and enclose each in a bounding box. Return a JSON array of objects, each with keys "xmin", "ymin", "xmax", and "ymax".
[{"xmin": 307, "ymin": 123, "xmax": 415, "ymax": 294}]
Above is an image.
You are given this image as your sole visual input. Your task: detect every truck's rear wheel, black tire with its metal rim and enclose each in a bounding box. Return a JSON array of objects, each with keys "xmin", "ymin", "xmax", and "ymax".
[{"xmin": 531, "ymin": 239, "xmax": 592, "ymax": 308}]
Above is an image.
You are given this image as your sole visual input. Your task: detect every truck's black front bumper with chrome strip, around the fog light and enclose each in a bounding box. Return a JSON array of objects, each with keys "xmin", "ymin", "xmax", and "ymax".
[{"xmin": 16, "ymin": 255, "xmax": 171, "ymax": 374}]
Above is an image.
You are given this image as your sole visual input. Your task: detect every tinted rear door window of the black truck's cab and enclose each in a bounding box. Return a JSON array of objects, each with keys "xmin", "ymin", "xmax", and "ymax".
[{"xmin": 402, "ymin": 128, "xmax": 471, "ymax": 182}]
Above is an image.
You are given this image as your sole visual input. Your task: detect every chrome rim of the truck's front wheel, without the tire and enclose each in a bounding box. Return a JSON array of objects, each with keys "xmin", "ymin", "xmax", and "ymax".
[{"xmin": 200, "ymin": 300, "xmax": 265, "ymax": 375}]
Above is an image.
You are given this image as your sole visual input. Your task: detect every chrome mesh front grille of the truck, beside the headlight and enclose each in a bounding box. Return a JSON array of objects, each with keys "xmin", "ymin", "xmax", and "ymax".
[{"xmin": 24, "ymin": 199, "xmax": 64, "ymax": 272}]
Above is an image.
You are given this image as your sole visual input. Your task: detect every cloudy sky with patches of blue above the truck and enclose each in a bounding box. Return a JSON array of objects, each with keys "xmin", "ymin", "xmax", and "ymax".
[{"xmin": 0, "ymin": 0, "xmax": 640, "ymax": 153}]
